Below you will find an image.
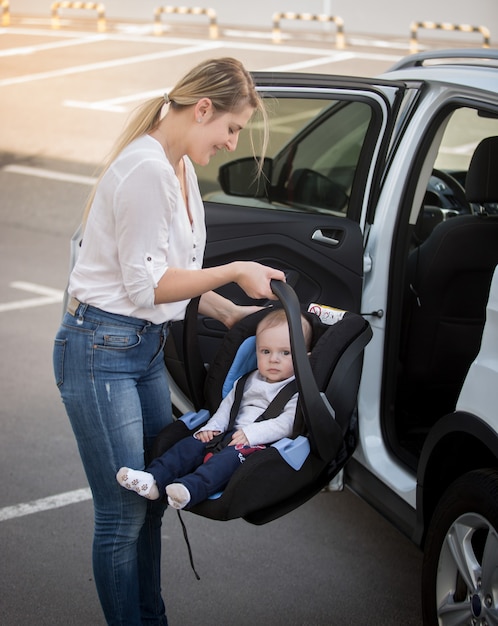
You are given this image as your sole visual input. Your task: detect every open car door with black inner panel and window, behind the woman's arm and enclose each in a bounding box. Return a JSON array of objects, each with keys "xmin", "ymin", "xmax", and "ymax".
[{"xmin": 166, "ymin": 73, "xmax": 403, "ymax": 413}]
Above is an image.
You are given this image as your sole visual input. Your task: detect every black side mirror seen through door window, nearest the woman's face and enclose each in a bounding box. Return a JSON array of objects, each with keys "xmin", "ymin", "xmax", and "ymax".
[{"xmin": 218, "ymin": 157, "xmax": 273, "ymax": 198}]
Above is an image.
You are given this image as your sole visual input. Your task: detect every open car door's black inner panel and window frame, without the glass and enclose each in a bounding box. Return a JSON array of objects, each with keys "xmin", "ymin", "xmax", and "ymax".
[{"xmin": 166, "ymin": 72, "xmax": 404, "ymax": 413}]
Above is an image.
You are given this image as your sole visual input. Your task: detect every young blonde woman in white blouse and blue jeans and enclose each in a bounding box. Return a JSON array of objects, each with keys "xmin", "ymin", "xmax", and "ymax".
[{"xmin": 54, "ymin": 58, "xmax": 284, "ymax": 626}]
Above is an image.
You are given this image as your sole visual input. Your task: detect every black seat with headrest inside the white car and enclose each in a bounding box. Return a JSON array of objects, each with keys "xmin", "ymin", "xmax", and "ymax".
[{"xmin": 398, "ymin": 137, "xmax": 498, "ymax": 425}]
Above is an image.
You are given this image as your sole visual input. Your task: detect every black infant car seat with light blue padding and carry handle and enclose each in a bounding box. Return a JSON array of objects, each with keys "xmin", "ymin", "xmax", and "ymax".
[{"xmin": 152, "ymin": 281, "xmax": 372, "ymax": 524}]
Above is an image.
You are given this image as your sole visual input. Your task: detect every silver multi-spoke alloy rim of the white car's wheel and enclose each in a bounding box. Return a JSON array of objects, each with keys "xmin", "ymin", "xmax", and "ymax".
[{"xmin": 436, "ymin": 513, "xmax": 498, "ymax": 626}]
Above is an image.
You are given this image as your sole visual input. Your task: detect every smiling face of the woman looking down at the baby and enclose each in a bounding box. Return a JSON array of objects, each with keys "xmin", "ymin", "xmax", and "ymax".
[{"xmin": 189, "ymin": 105, "xmax": 254, "ymax": 165}]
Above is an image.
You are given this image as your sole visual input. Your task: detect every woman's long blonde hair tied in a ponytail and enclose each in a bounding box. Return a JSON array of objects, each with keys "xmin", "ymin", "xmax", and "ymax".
[{"xmin": 83, "ymin": 57, "xmax": 268, "ymax": 222}]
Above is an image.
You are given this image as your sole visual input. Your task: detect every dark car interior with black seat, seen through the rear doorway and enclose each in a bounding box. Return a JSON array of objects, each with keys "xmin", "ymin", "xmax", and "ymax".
[{"xmin": 391, "ymin": 111, "xmax": 498, "ymax": 467}]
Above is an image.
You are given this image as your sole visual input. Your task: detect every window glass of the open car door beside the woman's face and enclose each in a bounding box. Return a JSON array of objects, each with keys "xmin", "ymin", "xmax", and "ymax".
[{"xmin": 197, "ymin": 98, "xmax": 373, "ymax": 216}]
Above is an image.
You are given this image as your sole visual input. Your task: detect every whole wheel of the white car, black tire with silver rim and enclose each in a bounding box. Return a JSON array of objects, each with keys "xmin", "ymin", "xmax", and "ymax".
[{"xmin": 422, "ymin": 470, "xmax": 498, "ymax": 626}]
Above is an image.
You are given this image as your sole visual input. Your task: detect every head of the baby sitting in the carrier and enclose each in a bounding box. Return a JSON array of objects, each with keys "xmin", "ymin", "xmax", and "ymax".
[{"xmin": 256, "ymin": 309, "xmax": 312, "ymax": 383}]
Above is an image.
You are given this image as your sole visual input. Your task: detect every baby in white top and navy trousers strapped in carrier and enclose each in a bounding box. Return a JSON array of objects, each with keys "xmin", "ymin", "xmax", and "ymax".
[{"xmin": 116, "ymin": 309, "xmax": 312, "ymax": 509}]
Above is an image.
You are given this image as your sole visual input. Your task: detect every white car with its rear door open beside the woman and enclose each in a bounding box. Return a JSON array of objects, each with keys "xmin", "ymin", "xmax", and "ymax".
[{"xmin": 73, "ymin": 49, "xmax": 498, "ymax": 626}]
